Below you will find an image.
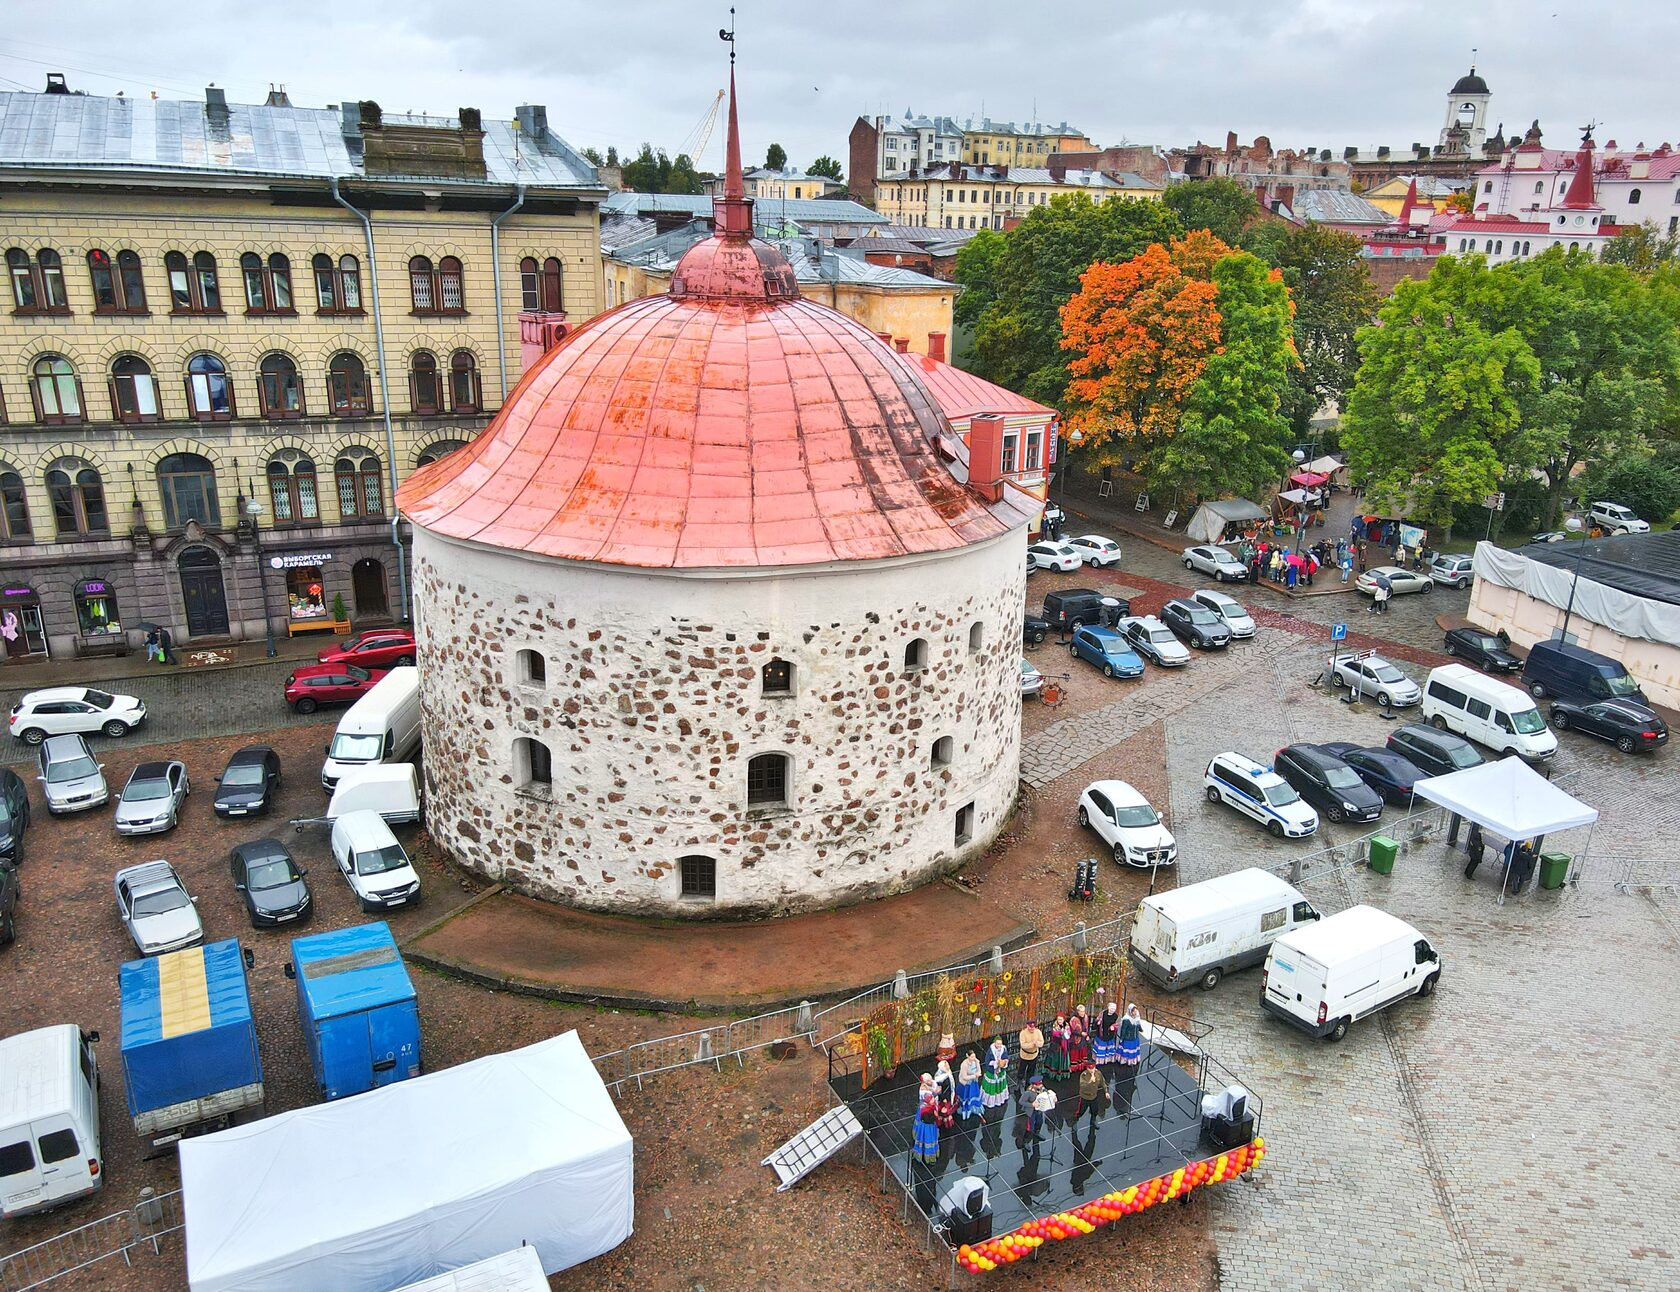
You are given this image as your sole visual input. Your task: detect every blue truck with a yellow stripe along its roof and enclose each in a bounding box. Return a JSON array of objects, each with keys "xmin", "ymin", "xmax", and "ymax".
[{"xmin": 119, "ymin": 939, "xmax": 262, "ymax": 1156}]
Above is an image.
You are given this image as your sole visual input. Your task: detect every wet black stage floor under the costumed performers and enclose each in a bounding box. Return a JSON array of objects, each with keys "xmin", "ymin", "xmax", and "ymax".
[{"xmin": 830, "ymin": 1037, "xmax": 1218, "ymax": 1235}]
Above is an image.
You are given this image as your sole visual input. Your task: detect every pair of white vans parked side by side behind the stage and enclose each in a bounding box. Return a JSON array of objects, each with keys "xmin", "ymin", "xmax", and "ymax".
[{"xmin": 1131, "ymin": 867, "xmax": 1441, "ymax": 1040}]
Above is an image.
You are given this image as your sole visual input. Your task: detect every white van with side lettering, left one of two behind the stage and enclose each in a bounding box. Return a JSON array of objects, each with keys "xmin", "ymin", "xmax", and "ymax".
[{"xmin": 1132, "ymin": 867, "xmax": 1319, "ymax": 991}]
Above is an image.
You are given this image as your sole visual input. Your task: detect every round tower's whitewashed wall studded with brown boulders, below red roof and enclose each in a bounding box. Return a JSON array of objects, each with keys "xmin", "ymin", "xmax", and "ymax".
[{"xmin": 415, "ymin": 529, "xmax": 1025, "ymax": 916}]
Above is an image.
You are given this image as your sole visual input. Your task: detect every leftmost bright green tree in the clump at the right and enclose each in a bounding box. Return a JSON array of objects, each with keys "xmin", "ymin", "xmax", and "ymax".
[{"xmin": 1342, "ymin": 268, "xmax": 1541, "ymax": 528}]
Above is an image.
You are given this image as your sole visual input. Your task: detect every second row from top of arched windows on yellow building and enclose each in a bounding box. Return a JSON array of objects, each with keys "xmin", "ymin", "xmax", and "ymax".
[{"xmin": 13, "ymin": 349, "xmax": 484, "ymax": 427}]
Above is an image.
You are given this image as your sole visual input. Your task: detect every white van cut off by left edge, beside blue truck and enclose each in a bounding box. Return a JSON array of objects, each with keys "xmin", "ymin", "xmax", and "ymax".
[{"xmin": 0, "ymin": 1023, "xmax": 104, "ymax": 1216}]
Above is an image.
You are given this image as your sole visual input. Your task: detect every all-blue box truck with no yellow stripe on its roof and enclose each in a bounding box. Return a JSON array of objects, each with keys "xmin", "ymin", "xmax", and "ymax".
[{"xmin": 286, "ymin": 921, "xmax": 420, "ymax": 1099}]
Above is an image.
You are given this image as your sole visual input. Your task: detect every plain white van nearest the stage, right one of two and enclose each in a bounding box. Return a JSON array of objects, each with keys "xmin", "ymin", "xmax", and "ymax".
[{"xmin": 1260, "ymin": 906, "xmax": 1441, "ymax": 1040}]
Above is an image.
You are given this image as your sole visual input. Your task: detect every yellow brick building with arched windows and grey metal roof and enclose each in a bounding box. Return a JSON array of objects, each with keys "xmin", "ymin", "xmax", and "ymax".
[{"xmin": 0, "ymin": 89, "xmax": 606, "ymax": 660}]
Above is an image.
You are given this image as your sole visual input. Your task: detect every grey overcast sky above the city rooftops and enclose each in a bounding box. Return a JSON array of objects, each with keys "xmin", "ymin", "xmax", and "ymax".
[{"xmin": 13, "ymin": 0, "xmax": 1680, "ymax": 170}]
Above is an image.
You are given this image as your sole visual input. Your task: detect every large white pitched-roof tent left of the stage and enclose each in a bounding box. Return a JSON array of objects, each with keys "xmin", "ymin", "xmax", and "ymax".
[{"xmin": 180, "ymin": 1032, "xmax": 635, "ymax": 1292}]
